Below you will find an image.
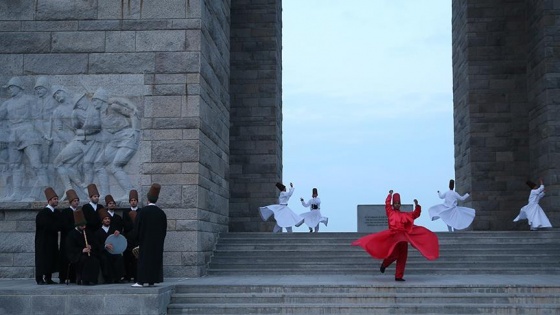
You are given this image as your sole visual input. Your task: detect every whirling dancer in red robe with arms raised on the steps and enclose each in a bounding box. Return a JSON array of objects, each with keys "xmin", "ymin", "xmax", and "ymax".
[{"xmin": 352, "ymin": 190, "xmax": 439, "ymax": 281}]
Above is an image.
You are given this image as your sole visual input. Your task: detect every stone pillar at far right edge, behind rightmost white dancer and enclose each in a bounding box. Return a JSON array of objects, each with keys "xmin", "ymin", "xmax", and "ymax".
[{"xmin": 527, "ymin": 0, "xmax": 560, "ymax": 226}]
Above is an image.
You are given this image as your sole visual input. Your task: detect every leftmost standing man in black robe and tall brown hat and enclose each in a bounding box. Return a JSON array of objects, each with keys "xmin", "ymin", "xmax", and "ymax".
[{"xmin": 35, "ymin": 187, "xmax": 61, "ymax": 285}]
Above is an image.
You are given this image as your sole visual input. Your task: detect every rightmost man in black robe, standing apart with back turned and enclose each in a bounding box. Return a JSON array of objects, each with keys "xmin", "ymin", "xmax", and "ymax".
[{"xmin": 132, "ymin": 184, "xmax": 167, "ymax": 288}]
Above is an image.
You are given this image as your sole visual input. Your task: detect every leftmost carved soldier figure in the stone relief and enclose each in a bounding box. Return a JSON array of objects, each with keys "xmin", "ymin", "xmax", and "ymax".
[{"xmin": 0, "ymin": 77, "xmax": 47, "ymax": 201}]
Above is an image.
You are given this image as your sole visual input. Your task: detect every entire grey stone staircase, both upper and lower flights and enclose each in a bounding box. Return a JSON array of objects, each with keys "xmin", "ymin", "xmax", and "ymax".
[{"xmin": 168, "ymin": 230, "xmax": 560, "ymax": 314}]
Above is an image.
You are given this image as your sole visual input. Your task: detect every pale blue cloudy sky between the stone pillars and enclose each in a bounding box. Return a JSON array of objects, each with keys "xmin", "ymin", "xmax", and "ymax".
[{"xmin": 282, "ymin": 0, "xmax": 458, "ymax": 232}]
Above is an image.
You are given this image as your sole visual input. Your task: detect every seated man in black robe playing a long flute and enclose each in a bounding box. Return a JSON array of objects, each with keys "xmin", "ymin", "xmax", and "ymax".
[{"xmin": 66, "ymin": 208, "xmax": 100, "ymax": 285}]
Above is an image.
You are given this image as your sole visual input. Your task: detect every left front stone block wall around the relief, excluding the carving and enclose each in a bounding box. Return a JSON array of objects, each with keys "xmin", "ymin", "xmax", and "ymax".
[{"xmin": 0, "ymin": 0, "xmax": 238, "ymax": 277}]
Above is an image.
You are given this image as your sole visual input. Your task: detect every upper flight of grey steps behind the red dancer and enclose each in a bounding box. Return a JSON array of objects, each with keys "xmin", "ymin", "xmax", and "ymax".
[{"xmin": 208, "ymin": 231, "xmax": 560, "ymax": 275}]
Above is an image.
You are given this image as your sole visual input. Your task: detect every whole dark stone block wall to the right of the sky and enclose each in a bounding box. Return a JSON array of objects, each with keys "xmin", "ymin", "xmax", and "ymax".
[{"xmin": 453, "ymin": 0, "xmax": 560, "ymax": 230}]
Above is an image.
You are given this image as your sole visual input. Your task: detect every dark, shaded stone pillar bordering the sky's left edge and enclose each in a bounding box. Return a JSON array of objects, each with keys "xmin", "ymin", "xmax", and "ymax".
[{"xmin": 229, "ymin": 0, "xmax": 282, "ymax": 232}]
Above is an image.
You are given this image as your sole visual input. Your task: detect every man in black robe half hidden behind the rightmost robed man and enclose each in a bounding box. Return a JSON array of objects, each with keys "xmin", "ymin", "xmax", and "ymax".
[{"xmin": 123, "ymin": 189, "xmax": 141, "ymax": 281}]
